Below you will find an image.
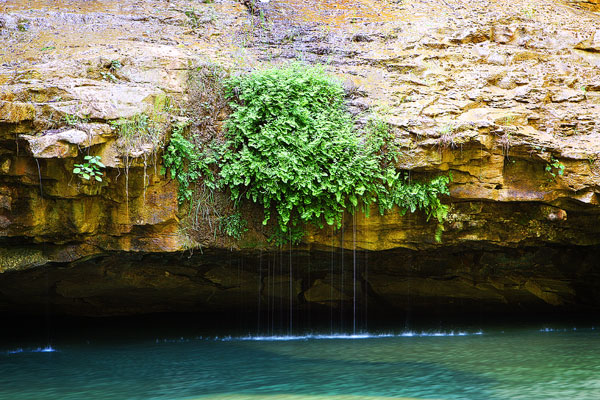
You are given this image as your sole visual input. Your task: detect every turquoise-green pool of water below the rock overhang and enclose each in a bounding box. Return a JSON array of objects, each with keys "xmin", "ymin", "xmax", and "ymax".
[{"xmin": 0, "ymin": 326, "xmax": 600, "ymax": 400}]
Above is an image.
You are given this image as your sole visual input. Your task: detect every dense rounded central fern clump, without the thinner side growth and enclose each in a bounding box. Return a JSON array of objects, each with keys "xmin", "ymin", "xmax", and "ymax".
[{"xmin": 220, "ymin": 66, "xmax": 368, "ymax": 232}]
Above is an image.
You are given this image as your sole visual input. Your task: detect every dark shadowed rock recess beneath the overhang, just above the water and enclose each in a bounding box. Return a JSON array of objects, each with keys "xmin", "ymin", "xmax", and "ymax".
[{"xmin": 0, "ymin": 246, "xmax": 600, "ymax": 322}]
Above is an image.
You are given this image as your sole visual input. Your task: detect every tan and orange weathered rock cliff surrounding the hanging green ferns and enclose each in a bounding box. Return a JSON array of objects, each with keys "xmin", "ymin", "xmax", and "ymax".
[{"xmin": 0, "ymin": 0, "xmax": 600, "ymax": 314}]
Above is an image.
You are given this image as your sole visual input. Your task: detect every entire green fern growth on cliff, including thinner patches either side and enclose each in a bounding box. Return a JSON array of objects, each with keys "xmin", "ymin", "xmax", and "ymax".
[{"xmin": 165, "ymin": 65, "xmax": 449, "ymax": 242}]
